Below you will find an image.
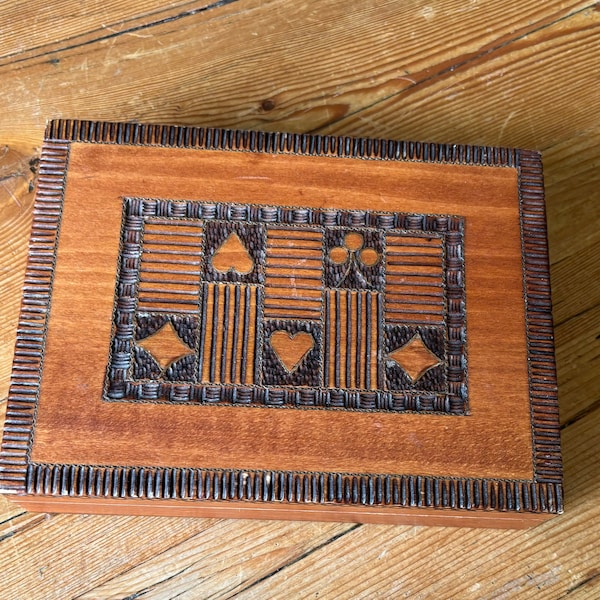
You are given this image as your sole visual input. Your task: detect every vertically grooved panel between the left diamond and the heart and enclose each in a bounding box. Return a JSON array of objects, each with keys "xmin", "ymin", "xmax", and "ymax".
[{"xmin": 198, "ymin": 283, "xmax": 260, "ymax": 384}]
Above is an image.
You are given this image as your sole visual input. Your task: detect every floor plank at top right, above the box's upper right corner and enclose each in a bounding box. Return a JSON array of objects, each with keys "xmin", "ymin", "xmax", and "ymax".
[{"xmin": 318, "ymin": 3, "xmax": 600, "ymax": 149}]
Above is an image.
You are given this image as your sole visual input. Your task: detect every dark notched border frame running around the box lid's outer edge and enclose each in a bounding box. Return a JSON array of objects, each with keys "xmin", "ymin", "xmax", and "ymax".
[{"xmin": 0, "ymin": 120, "xmax": 563, "ymax": 513}]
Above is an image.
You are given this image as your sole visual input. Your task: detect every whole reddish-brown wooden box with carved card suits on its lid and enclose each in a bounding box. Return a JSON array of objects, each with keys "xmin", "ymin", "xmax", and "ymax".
[{"xmin": 0, "ymin": 121, "xmax": 562, "ymax": 527}]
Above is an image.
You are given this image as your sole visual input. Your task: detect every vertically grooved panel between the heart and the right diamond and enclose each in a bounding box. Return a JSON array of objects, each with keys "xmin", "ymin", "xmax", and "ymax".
[{"xmin": 324, "ymin": 290, "xmax": 379, "ymax": 390}]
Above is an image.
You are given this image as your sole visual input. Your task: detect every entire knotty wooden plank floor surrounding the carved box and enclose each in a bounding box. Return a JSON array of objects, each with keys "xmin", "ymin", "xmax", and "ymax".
[{"xmin": 0, "ymin": 0, "xmax": 600, "ymax": 600}]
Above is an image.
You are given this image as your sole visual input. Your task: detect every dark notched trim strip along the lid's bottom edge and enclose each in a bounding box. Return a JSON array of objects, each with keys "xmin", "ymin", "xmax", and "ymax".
[{"xmin": 21, "ymin": 464, "xmax": 562, "ymax": 513}]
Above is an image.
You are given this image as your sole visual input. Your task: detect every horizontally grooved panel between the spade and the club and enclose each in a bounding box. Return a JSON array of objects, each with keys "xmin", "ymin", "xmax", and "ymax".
[{"xmin": 264, "ymin": 227, "xmax": 323, "ymax": 321}]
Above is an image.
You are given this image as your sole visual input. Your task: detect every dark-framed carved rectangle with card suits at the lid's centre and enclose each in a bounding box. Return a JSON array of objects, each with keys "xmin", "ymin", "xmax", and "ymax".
[{"xmin": 106, "ymin": 198, "xmax": 467, "ymax": 414}]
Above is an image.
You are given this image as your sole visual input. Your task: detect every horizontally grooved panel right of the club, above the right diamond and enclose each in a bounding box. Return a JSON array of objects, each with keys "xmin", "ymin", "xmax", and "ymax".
[{"xmin": 385, "ymin": 233, "xmax": 445, "ymax": 325}]
